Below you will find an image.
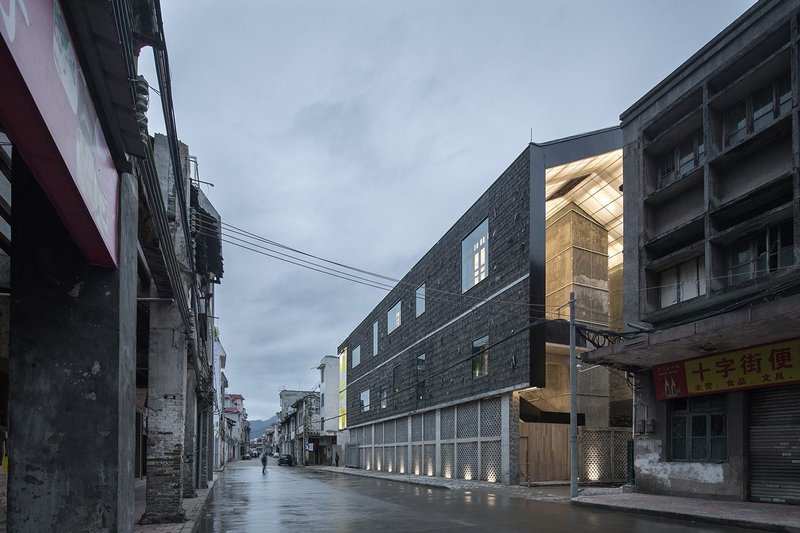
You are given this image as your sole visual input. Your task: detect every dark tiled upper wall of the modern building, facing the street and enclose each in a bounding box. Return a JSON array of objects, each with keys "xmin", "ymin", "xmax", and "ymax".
[{"xmin": 339, "ymin": 144, "xmax": 530, "ymax": 426}]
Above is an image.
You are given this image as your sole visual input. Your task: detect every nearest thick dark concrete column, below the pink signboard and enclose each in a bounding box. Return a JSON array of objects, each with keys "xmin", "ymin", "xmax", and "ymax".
[{"xmin": 7, "ymin": 151, "xmax": 138, "ymax": 532}]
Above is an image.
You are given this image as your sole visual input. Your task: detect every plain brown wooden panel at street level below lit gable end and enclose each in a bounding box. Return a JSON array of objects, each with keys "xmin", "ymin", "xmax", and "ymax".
[{"xmin": 519, "ymin": 422, "xmax": 569, "ymax": 481}]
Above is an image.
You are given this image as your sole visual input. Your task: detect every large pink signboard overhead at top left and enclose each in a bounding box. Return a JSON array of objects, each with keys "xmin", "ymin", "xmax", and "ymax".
[{"xmin": 0, "ymin": 0, "xmax": 119, "ymax": 267}]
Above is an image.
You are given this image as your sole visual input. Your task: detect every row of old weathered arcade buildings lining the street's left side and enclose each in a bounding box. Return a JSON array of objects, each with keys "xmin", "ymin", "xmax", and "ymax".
[{"xmin": 0, "ymin": 0, "xmax": 234, "ymax": 531}]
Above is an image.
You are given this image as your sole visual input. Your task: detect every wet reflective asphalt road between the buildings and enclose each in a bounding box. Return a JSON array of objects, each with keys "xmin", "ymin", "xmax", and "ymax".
[{"xmin": 198, "ymin": 458, "xmax": 760, "ymax": 533}]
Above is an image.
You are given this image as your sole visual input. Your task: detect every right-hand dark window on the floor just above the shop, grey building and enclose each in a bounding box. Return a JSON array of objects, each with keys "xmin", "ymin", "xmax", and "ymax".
[{"xmin": 728, "ymin": 219, "xmax": 794, "ymax": 285}]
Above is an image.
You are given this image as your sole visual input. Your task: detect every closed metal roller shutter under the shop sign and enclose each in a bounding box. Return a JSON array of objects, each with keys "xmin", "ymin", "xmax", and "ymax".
[{"xmin": 749, "ymin": 385, "xmax": 800, "ymax": 505}]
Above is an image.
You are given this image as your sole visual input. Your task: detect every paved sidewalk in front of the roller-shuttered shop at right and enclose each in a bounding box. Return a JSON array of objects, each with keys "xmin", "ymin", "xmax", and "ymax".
[{"xmin": 572, "ymin": 492, "xmax": 800, "ymax": 533}]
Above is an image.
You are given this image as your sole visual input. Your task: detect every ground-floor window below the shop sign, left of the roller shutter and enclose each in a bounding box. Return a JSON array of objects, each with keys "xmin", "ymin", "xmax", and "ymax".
[{"xmin": 670, "ymin": 394, "xmax": 728, "ymax": 462}]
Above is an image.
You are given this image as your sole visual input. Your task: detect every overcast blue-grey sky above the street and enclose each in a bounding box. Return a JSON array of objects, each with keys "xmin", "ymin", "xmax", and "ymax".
[{"xmin": 142, "ymin": 0, "xmax": 753, "ymax": 420}]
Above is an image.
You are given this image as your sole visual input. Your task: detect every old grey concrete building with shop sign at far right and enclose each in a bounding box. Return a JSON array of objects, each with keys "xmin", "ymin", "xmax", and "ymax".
[{"xmin": 585, "ymin": 0, "xmax": 800, "ymax": 504}]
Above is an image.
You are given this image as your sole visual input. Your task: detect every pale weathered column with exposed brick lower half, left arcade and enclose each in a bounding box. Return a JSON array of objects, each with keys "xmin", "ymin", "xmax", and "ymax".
[{"xmin": 142, "ymin": 302, "xmax": 186, "ymax": 524}]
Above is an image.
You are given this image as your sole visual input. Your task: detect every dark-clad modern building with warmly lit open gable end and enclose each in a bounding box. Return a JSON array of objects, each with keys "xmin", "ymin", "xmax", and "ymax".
[{"xmin": 339, "ymin": 128, "xmax": 629, "ymax": 483}]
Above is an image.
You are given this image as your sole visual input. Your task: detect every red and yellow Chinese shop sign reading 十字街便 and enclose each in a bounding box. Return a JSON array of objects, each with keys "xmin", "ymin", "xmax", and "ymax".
[{"xmin": 653, "ymin": 339, "xmax": 800, "ymax": 400}]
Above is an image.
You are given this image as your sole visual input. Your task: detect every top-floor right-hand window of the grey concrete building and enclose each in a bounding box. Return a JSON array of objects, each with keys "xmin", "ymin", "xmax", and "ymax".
[{"xmin": 725, "ymin": 74, "xmax": 792, "ymax": 146}]
